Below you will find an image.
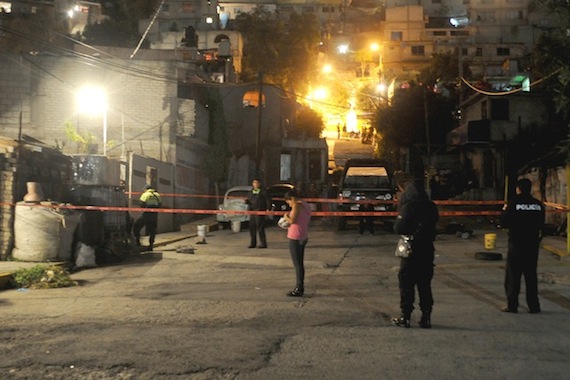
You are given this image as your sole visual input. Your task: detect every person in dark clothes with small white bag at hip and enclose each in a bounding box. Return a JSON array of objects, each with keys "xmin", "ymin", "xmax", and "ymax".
[{"xmin": 392, "ymin": 173, "xmax": 439, "ymax": 329}]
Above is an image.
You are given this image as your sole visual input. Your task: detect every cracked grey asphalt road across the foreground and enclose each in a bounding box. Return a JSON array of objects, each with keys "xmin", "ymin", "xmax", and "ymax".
[{"xmin": 0, "ymin": 220, "xmax": 570, "ymax": 379}]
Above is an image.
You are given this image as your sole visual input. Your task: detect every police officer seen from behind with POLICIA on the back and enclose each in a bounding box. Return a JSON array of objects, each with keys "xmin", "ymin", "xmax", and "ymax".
[{"xmin": 499, "ymin": 178, "xmax": 545, "ymax": 313}]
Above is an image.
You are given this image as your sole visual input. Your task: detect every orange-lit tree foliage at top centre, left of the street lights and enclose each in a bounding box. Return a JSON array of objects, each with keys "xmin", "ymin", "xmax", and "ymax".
[{"xmin": 235, "ymin": 7, "xmax": 320, "ymax": 92}]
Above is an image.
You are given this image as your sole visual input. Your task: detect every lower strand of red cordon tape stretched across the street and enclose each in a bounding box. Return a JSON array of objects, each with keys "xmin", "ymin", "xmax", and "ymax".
[{"xmin": 4, "ymin": 200, "xmax": 568, "ymax": 217}]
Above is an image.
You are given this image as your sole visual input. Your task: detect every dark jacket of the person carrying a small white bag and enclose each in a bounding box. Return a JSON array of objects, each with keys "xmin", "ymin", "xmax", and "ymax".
[{"xmin": 394, "ymin": 183, "xmax": 439, "ymax": 242}]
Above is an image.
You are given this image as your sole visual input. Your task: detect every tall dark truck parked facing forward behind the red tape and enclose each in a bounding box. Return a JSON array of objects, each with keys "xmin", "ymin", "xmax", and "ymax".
[{"xmin": 332, "ymin": 159, "xmax": 396, "ymax": 230}]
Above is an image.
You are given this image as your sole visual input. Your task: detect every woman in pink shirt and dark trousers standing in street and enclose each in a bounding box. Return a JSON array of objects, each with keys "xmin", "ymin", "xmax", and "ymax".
[{"xmin": 284, "ymin": 190, "xmax": 311, "ymax": 297}]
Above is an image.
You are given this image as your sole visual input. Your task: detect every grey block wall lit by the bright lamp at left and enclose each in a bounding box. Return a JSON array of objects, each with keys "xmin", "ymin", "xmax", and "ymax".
[{"xmin": 0, "ymin": 55, "xmax": 195, "ymax": 163}]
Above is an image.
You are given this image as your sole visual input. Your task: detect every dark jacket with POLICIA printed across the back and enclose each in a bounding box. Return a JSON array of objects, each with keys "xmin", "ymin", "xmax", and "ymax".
[{"xmin": 499, "ymin": 194, "xmax": 545, "ymax": 247}]
